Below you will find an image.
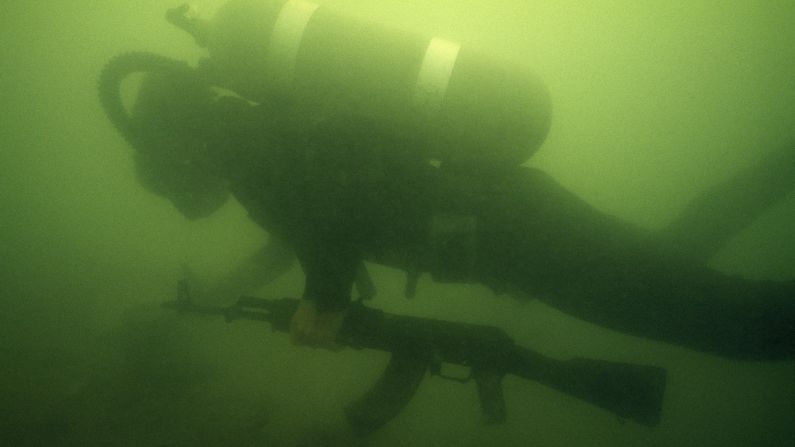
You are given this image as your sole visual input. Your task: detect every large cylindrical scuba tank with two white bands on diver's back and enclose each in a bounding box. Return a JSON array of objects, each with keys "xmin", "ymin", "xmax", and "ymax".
[{"xmin": 167, "ymin": 0, "xmax": 551, "ymax": 166}]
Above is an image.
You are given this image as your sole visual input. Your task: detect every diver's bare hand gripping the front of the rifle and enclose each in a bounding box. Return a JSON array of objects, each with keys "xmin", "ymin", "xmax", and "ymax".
[{"xmin": 290, "ymin": 300, "xmax": 345, "ymax": 351}]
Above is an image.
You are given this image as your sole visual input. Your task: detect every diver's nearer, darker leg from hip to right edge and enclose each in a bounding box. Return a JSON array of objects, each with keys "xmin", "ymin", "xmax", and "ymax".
[{"xmin": 478, "ymin": 170, "xmax": 795, "ymax": 359}]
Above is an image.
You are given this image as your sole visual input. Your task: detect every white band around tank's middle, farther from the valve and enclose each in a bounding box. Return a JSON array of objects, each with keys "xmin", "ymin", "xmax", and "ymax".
[{"xmin": 414, "ymin": 37, "xmax": 461, "ymax": 117}]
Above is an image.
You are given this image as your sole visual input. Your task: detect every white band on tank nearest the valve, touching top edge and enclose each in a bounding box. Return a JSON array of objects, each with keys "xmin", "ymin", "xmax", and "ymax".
[{"xmin": 265, "ymin": 0, "xmax": 319, "ymax": 91}]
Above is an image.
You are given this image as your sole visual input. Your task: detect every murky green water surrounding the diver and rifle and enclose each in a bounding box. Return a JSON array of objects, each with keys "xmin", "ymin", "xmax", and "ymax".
[{"xmin": 0, "ymin": 0, "xmax": 795, "ymax": 447}]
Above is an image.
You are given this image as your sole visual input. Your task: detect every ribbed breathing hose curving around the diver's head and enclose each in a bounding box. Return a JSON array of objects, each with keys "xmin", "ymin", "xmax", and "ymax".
[{"xmin": 97, "ymin": 52, "xmax": 196, "ymax": 147}]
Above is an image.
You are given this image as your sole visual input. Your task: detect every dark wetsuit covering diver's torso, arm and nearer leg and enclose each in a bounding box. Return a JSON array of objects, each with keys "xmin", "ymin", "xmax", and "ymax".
[{"xmin": 208, "ymin": 97, "xmax": 795, "ymax": 359}]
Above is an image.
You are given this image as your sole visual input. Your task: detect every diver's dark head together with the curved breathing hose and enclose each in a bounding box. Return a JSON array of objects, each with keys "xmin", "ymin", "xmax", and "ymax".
[{"xmin": 100, "ymin": 53, "xmax": 229, "ymax": 219}]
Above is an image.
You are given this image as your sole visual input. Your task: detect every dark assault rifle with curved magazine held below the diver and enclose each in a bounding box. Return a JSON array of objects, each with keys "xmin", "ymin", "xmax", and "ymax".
[{"xmin": 164, "ymin": 281, "xmax": 666, "ymax": 432}]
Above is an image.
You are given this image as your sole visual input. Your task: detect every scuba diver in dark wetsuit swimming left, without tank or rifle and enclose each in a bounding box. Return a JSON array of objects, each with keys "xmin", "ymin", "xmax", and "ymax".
[{"xmin": 100, "ymin": 53, "xmax": 795, "ymax": 360}]
